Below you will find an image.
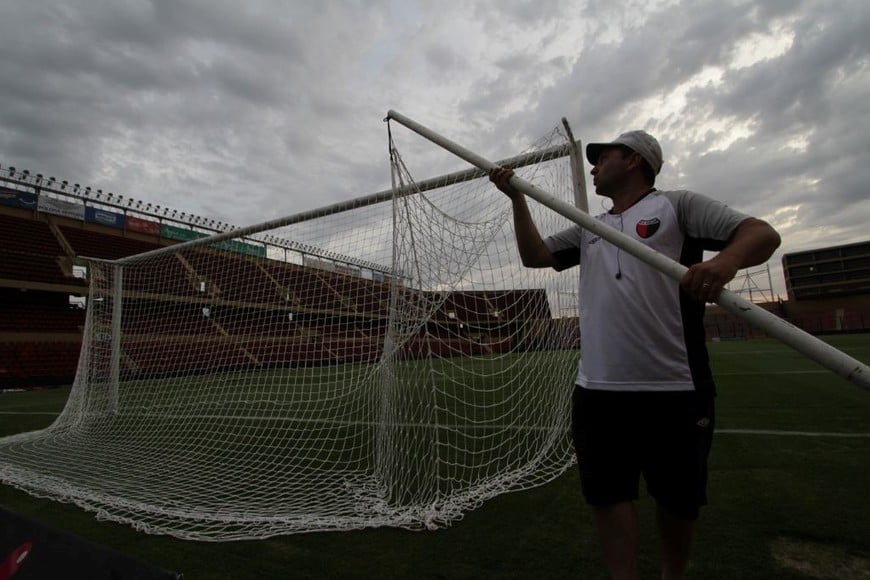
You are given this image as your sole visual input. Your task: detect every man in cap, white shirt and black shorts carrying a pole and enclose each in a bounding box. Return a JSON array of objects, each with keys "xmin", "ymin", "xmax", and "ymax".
[{"xmin": 490, "ymin": 131, "xmax": 780, "ymax": 579}]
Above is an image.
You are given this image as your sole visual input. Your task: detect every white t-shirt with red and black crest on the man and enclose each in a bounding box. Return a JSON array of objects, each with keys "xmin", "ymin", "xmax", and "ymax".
[{"xmin": 544, "ymin": 191, "xmax": 749, "ymax": 391}]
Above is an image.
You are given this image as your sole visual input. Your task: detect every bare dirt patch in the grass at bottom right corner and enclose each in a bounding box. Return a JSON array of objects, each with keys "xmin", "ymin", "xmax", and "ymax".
[{"xmin": 770, "ymin": 538, "xmax": 870, "ymax": 580}]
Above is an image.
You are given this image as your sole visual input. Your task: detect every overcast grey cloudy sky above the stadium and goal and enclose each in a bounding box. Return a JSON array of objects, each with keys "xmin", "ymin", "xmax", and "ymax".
[{"xmin": 0, "ymin": 0, "xmax": 870, "ymax": 291}]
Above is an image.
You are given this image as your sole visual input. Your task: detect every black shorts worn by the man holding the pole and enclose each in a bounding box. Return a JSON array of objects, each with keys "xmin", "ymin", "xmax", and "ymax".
[{"xmin": 572, "ymin": 386, "xmax": 715, "ymax": 519}]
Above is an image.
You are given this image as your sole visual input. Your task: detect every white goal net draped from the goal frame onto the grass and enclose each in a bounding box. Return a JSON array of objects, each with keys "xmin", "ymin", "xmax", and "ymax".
[{"xmin": 0, "ymin": 124, "xmax": 579, "ymax": 541}]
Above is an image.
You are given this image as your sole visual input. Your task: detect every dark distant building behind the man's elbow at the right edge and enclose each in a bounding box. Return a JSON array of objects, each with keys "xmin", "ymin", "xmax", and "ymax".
[{"xmin": 782, "ymin": 241, "xmax": 870, "ymax": 300}]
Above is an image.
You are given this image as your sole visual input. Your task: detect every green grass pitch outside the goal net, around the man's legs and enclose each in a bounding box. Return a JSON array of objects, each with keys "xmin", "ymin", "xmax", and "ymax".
[{"xmin": 0, "ymin": 335, "xmax": 870, "ymax": 579}]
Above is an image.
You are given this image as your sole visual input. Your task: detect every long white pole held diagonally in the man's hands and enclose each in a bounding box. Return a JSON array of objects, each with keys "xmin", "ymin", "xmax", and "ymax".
[{"xmin": 387, "ymin": 110, "xmax": 870, "ymax": 389}]
